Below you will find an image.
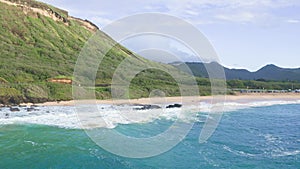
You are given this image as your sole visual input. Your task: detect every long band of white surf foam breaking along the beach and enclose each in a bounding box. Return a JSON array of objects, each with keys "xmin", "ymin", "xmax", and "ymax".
[{"xmin": 0, "ymin": 100, "xmax": 300, "ymax": 129}]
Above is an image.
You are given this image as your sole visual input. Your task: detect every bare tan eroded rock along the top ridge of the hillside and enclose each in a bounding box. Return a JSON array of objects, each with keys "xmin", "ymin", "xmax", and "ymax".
[{"xmin": 0, "ymin": 0, "xmax": 99, "ymax": 32}]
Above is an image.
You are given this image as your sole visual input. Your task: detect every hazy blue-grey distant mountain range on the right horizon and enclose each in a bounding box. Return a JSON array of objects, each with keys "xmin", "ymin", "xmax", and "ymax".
[{"xmin": 172, "ymin": 62, "xmax": 300, "ymax": 81}]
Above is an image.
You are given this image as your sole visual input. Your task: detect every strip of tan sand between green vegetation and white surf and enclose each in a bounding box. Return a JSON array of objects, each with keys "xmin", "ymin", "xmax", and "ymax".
[{"xmin": 32, "ymin": 93, "xmax": 300, "ymax": 106}]
